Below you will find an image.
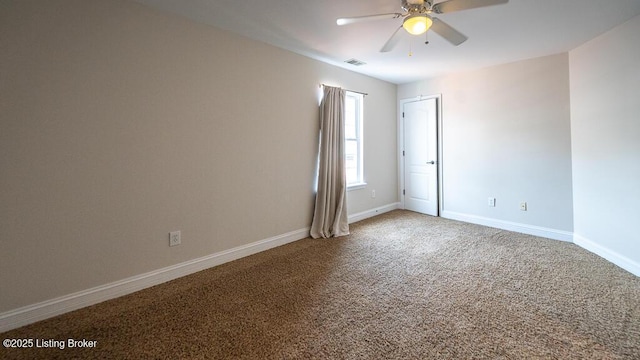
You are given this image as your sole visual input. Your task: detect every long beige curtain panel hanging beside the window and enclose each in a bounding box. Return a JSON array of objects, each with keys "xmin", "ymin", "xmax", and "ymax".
[{"xmin": 311, "ymin": 86, "xmax": 349, "ymax": 239}]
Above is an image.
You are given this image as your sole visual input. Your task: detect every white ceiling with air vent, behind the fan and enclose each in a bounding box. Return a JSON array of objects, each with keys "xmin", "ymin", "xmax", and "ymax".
[{"xmin": 134, "ymin": 0, "xmax": 640, "ymax": 84}]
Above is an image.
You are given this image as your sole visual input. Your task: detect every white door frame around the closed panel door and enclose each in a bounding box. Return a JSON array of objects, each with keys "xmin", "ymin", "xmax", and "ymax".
[{"xmin": 397, "ymin": 94, "xmax": 444, "ymax": 216}]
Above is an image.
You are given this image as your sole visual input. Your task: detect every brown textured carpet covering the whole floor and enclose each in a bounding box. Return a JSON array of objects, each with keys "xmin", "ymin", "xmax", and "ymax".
[{"xmin": 0, "ymin": 211, "xmax": 640, "ymax": 359}]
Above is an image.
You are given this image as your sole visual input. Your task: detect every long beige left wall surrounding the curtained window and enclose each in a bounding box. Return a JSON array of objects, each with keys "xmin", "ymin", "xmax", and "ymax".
[{"xmin": 0, "ymin": 0, "xmax": 397, "ymax": 313}]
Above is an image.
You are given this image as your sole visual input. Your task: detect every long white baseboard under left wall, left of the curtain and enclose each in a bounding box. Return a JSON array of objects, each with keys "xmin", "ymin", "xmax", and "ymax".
[{"xmin": 0, "ymin": 228, "xmax": 309, "ymax": 332}]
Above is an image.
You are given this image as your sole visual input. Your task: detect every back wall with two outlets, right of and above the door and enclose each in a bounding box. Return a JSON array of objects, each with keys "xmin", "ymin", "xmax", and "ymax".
[{"xmin": 398, "ymin": 53, "xmax": 573, "ymax": 233}]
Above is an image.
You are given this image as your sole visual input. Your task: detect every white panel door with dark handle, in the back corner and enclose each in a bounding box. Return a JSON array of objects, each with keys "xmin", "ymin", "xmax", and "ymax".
[{"xmin": 403, "ymin": 98, "xmax": 438, "ymax": 216}]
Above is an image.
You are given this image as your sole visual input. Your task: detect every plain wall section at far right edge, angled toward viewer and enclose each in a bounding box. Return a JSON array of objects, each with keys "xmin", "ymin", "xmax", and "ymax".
[{"xmin": 569, "ymin": 16, "xmax": 640, "ymax": 276}]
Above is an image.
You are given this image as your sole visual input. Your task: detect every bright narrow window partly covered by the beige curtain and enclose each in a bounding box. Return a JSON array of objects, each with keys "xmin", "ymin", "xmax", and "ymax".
[{"xmin": 344, "ymin": 91, "xmax": 364, "ymax": 187}]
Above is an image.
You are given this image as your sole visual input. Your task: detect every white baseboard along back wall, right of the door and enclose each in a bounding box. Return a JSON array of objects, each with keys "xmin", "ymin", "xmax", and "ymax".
[{"xmin": 441, "ymin": 210, "xmax": 573, "ymax": 242}]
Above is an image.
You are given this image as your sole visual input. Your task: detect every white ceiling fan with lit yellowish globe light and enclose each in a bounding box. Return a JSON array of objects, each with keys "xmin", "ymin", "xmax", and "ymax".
[{"xmin": 336, "ymin": 0, "xmax": 509, "ymax": 52}]
